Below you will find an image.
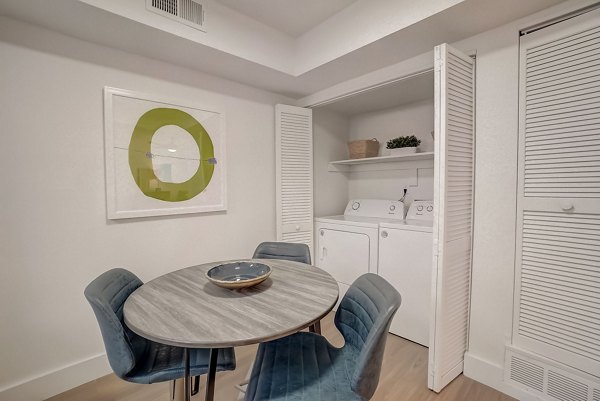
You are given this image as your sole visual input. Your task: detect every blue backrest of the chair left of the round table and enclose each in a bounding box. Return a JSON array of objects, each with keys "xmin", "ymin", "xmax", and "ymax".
[{"xmin": 84, "ymin": 268, "xmax": 147, "ymax": 378}]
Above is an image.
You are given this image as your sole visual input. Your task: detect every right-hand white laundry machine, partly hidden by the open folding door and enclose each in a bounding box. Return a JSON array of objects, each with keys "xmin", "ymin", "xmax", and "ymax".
[{"xmin": 378, "ymin": 201, "xmax": 433, "ymax": 346}]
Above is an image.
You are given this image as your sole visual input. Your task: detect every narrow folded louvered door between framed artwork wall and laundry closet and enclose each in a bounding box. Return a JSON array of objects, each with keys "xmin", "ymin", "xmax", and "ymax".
[{"xmin": 275, "ymin": 104, "xmax": 314, "ymax": 255}]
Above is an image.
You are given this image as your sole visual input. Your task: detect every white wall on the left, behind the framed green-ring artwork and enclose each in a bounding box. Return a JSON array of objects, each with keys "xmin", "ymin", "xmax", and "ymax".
[{"xmin": 0, "ymin": 18, "xmax": 290, "ymax": 401}]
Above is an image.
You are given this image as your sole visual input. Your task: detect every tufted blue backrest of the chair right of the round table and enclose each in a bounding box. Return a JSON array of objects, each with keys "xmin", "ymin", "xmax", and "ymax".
[{"xmin": 335, "ymin": 273, "xmax": 401, "ymax": 400}]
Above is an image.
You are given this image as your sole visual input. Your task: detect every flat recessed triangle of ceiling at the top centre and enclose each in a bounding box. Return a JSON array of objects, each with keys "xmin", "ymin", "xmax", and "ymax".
[{"xmin": 216, "ymin": 0, "xmax": 356, "ymax": 38}]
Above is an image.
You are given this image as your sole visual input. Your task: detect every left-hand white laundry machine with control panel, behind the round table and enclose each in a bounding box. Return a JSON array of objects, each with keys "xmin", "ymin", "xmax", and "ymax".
[{"xmin": 315, "ymin": 199, "xmax": 404, "ymax": 307}]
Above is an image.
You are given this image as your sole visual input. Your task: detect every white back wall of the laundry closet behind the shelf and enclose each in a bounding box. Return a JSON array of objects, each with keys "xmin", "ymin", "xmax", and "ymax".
[{"xmin": 348, "ymin": 99, "xmax": 434, "ymax": 205}]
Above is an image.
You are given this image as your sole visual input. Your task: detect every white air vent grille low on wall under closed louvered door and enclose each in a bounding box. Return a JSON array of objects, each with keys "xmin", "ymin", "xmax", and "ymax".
[{"xmin": 504, "ymin": 346, "xmax": 600, "ymax": 401}]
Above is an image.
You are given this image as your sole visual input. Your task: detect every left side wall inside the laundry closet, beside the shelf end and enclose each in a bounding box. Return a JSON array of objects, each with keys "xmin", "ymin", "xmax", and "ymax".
[{"xmin": 313, "ymin": 108, "xmax": 349, "ymax": 217}]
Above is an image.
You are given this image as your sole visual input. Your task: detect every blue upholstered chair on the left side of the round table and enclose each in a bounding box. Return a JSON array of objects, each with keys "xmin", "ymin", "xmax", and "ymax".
[{"xmin": 84, "ymin": 268, "xmax": 235, "ymax": 390}]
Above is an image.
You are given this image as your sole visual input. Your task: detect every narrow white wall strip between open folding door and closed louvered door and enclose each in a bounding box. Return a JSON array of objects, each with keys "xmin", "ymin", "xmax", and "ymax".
[{"xmin": 461, "ymin": 23, "xmax": 518, "ymax": 391}]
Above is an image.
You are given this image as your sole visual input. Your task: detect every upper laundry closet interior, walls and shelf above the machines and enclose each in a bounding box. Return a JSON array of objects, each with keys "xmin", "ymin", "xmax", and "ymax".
[{"xmin": 313, "ymin": 70, "xmax": 434, "ymax": 212}]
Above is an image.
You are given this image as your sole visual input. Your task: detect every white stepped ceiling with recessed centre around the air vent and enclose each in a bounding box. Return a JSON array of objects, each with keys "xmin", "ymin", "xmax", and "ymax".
[{"xmin": 0, "ymin": 0, "xmax": 564, "ymax": 98}]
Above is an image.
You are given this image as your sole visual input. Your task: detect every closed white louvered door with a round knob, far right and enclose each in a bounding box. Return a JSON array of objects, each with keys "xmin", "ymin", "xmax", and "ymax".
[{"xmin": 513, "ymin": 10, "xmax": 600, "ymax": 378}]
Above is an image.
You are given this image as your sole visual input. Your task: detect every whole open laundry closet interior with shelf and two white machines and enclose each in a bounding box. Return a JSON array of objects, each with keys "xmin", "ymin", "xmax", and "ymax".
[{"xmin": 313, "ymin": 70, "xmax": 434, "ymax": 346}]
